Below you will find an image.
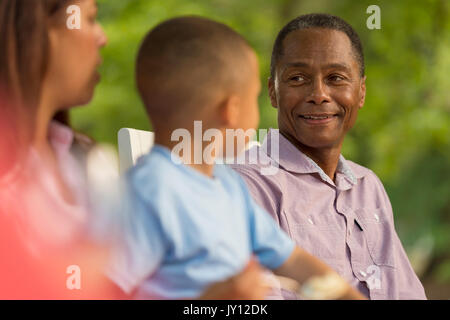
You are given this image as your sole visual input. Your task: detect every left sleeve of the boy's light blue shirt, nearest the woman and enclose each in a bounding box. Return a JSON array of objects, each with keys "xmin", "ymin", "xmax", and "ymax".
[{"xmin": 106, "ymin": 178, "xmax": 167, "ymax": 295}]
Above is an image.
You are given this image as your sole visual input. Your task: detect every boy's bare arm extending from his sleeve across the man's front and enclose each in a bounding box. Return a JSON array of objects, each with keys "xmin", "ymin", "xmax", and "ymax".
[{"xmin": 273, "ymin": 247, "xmax": 366, "ymax": 300}]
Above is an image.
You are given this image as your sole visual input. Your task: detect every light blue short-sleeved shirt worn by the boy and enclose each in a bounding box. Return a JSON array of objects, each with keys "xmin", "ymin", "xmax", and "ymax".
[{"xmin": 108, "ymin": 145, "xmax": 294, "ymax": 299}]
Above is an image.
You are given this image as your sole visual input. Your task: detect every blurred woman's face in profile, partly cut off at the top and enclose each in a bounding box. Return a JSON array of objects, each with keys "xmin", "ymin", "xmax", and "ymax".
[{"xmin": 44, "ymin": 0, "xmax": 107, "ymax": 111}]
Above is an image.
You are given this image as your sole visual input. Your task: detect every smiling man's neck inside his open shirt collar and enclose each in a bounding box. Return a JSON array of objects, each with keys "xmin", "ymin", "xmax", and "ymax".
[{"xmin": 282, "ymin": 133, "xmax": 342, "ymax": 181}]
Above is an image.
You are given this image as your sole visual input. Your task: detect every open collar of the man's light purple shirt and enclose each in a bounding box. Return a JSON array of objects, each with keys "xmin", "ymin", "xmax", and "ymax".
[{"xmin": 261, "ymin": 129, "xmax": 365, "ymax": 185}]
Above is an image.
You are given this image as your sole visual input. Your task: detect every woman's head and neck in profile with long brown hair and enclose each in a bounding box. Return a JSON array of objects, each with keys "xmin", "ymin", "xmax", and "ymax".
[{"xmin": 0, "ymin": 0, "xmax": 106, "ymax": 163}]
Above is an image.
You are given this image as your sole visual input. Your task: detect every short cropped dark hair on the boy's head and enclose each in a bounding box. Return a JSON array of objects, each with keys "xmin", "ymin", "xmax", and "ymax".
[{"xmin": 136, "ymin": 16, "xmax": 251, "ymax": 125}]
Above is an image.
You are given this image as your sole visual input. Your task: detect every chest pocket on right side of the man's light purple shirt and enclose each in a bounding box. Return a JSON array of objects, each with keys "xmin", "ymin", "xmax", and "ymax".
[{"xmin": 355, "ymin": 208, "xmax": 395, "ymax": 268}]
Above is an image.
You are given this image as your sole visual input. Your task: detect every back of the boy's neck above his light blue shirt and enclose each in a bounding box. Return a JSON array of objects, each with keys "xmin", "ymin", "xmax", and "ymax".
[{"xmin": 155, "ymin": 132, "xmax": 214, "ymax": 177}]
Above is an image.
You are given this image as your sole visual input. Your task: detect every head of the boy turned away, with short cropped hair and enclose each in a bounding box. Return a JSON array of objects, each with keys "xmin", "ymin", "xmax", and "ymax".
[{"xmin": 136, "ymin": 17, "xmax": 260, "ymax": 135}]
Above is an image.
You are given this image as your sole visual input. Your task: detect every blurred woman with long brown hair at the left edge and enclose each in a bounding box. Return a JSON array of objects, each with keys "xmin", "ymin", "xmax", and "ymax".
[{"xmin": 0, "ymin": 0, "xmax": 116, "ymax": 299}]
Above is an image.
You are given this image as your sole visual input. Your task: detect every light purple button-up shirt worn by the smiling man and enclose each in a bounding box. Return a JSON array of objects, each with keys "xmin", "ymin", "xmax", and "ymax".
[{"xmin": 232, "ymin": 130, "xmax": 426, "ymax": 299}]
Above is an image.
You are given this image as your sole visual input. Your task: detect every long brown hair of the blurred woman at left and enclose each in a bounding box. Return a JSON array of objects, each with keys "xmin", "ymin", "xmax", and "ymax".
[{"xmin": 0, "ymin": 0, "xmax": 96, "ymax": 176}]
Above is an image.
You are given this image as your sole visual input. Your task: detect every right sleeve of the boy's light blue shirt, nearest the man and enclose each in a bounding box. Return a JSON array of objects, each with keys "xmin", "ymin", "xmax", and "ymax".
[{"xmin": 248, "ymin": 196, "xmax": 295, "ymax": 270}]
